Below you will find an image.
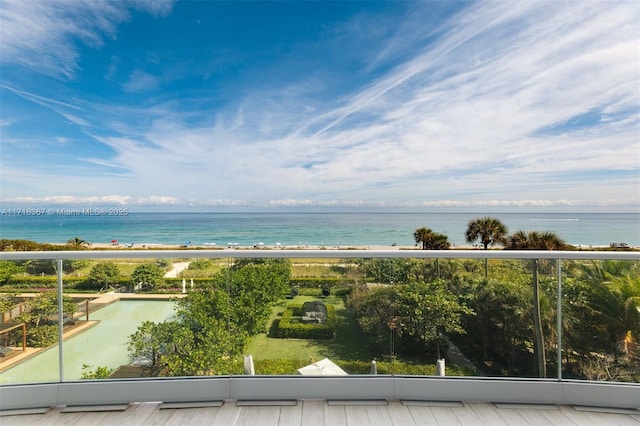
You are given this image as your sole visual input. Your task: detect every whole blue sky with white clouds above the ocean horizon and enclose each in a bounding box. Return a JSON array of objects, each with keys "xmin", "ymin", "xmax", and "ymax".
[{"xmin": 0, "ymin": 0, "xmax": 640, "ymax": 210}]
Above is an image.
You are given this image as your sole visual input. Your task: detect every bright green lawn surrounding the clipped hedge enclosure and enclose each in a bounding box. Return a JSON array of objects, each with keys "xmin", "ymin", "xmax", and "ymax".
[{"xmin": 246, "ymin": 296, "xmax": 373, "ymax": 360}]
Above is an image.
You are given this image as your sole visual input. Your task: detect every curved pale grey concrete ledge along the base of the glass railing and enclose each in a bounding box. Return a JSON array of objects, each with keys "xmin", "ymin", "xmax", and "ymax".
[{"xmin": 0, "ymin": 375, "xmax": 640, "ymax": 410}]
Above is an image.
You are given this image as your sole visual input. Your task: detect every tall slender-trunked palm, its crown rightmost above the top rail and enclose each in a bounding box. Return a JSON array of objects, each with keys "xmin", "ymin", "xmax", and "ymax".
[{"xmin": 506, "ymin": 231, "xmax": 567, "ymax": 377}]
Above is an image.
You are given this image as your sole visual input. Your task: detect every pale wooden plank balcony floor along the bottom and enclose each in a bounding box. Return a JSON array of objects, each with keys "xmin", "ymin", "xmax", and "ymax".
[{"xmin": 0, "ymin": 400, "xmax": 640, "ymax": 426}]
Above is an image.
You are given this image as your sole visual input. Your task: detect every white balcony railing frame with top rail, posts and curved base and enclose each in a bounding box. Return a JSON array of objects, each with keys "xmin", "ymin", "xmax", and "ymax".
[{"xmin": 0, "ymin": 249, "xmax": 640, "ymax": 409}]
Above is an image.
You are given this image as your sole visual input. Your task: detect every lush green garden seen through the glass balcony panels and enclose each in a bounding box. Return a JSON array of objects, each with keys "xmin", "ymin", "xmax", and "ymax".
[{"xmin": 0, "ymin": 233, "xmax": 640, "ymax": 382}]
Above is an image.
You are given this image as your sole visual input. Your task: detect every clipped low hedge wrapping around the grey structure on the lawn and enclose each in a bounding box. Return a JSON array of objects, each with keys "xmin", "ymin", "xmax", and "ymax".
[{"xmin": 274, "ymin": 305, "xmax": 336, "ymax": 339}]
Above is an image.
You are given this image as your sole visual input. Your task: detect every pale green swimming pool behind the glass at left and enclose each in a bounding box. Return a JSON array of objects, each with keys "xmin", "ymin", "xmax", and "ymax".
[{"xmin": 0, "ymin": 300, "xmax": 174, "ymax": 384}]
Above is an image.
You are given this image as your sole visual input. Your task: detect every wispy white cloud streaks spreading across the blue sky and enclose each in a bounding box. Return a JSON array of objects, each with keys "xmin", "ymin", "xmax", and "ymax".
[{"xmin": 0, "ymin": 0, "xmax": 640, "ymax": 208}]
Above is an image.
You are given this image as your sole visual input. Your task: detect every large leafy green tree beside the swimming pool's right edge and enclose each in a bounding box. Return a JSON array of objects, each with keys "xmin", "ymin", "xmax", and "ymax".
[{"xmin": 128, "ymin": 259, "xmax": 291, "ymax": 376}]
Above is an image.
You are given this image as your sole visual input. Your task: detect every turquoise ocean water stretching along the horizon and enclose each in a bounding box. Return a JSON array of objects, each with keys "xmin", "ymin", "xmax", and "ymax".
[{"xmin": 0, "ymin": 213, "xmax": 640, "ymax": 247}]
